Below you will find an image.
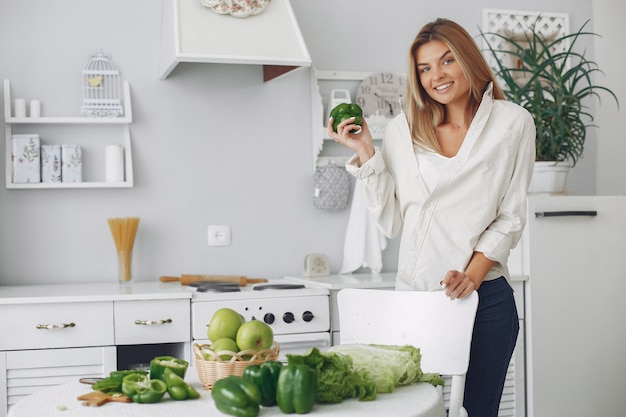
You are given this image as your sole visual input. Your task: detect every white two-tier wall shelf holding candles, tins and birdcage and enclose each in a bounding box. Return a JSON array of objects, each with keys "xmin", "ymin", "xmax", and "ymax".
[{"xmin": 4, "ymin": 80, "xmax": 134, "ymax": 189}]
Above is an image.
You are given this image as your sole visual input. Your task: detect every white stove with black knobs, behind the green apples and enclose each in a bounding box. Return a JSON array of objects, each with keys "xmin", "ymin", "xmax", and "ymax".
[{"xmin": 188, "ymin": 280, "xmax": 331, "ymax": 361}]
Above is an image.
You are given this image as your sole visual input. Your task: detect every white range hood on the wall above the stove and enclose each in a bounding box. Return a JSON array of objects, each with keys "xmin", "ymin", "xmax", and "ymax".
[{"xmin": 159, "ymin": 0, "xmax": 311, "ymax": 81}]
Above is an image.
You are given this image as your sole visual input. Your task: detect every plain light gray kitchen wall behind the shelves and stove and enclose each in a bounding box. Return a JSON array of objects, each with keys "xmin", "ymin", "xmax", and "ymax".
[{"xmin": 0, "ymin": 0, "xmax": 598, "ymax": 285}]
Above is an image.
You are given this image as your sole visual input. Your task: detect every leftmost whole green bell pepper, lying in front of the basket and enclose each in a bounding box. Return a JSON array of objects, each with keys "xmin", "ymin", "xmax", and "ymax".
[{"xmin": 211, "ymin": 375, "xmax": 261, "ymax": 417}]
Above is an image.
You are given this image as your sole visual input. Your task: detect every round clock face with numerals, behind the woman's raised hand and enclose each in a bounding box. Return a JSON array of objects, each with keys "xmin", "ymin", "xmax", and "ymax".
[{"xmin": 356, "ymin": 72, "xmax": 406, "ymax": 118}]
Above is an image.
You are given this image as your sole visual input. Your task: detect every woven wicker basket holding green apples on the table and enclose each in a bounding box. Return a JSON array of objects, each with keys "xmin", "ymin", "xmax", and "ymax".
[{"xmin": 193, "ymin": 341, "xmax": 280, "ymax": 390}]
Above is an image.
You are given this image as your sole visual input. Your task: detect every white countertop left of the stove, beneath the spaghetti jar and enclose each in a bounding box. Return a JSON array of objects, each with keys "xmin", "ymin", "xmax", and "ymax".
[{"xmin": 0, "ymin": 281, "xmax": 192, "ymax": 305}]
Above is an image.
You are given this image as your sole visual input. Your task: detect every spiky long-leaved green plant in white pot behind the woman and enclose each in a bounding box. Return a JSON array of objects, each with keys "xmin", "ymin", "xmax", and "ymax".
[{"xmin": 481, "ymin": 19, "xmax": 619, "ymax": 192}]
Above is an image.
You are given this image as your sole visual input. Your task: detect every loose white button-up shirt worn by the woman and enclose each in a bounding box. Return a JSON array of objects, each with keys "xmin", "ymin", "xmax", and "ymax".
[{"xmin": 346, "ymin": 84, "xmax": 535, "ymax": 290}]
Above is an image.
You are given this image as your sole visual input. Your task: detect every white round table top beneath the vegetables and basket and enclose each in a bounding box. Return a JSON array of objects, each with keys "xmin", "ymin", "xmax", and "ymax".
[{"xmin": 8, "ymin": 369, "xmax": 446, "ymax": 417}]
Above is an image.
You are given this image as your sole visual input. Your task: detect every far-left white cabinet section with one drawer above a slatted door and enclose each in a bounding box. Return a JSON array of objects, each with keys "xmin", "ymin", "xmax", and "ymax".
[{"xmin": 0, "ymin": 302, "xmax": 116, "ymax": 416}]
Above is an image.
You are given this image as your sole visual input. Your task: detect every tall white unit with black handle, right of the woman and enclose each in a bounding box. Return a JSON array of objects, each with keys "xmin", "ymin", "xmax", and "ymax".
[{"xmin": 526, "ymin": 195, "xmax": 626, "ymax": 417}]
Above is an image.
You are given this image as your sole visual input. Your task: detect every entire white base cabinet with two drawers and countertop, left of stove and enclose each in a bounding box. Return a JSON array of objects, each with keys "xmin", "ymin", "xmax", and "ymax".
[{"xmin": 0, "ymin": 282, "xmax": 191, "ymax": 417}]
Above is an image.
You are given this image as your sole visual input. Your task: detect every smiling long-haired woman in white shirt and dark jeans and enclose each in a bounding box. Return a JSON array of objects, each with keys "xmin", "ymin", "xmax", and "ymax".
[{"xmin": 328, "ymin": 19, "xmax": 535, "ymax": 417}]
